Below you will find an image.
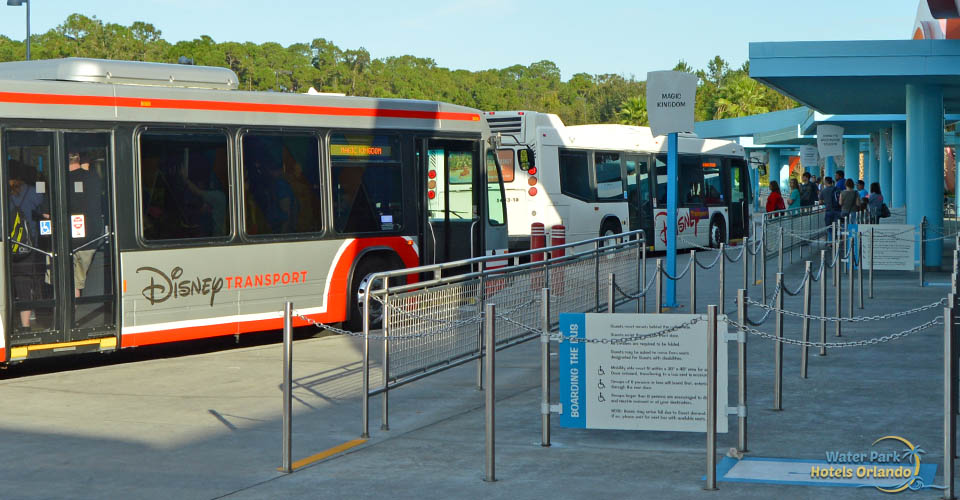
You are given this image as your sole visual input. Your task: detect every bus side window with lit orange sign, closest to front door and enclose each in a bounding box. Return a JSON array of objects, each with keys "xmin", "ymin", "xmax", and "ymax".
[{"xmin": 330, "ymin": 132, "xmax": 403, "ymax": 233}]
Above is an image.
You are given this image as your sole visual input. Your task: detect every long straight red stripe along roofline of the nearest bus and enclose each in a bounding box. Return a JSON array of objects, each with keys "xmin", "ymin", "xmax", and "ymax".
[{"xmin": 0, "ymin": 92, "xmax": 480, "ymax": 122}]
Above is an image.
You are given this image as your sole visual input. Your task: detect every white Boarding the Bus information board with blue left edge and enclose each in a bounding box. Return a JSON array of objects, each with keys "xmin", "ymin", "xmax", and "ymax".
[{"xmin": 559, "ymin": 313, "xmax": 728, "ymax": 432}]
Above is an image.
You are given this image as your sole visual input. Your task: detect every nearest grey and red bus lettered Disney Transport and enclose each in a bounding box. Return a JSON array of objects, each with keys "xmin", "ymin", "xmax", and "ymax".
[{"xmin": 0, "ymin": 59, "xmax": 507, "ymax": 363}]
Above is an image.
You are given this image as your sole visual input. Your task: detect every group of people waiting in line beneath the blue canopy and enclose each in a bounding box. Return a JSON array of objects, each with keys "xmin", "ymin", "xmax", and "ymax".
[{"xmin": 766, "ymin": 170, "xmax": 883, "ymax": 226}]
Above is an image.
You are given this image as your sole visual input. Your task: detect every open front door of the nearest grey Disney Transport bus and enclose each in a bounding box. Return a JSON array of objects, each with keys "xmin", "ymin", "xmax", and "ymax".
[{"xmin": 420, "ymin": 139, "xmax": 484, "ymax": 264}]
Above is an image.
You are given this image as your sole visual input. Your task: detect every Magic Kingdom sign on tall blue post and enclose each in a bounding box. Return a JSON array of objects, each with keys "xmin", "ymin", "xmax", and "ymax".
[{"xmin": 647, "ymin": 71, "xmax": 697, "ymax": 307}]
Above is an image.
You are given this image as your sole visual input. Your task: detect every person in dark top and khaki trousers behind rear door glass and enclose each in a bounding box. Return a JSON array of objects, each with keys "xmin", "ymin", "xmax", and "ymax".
[{"xmin": 67, "ymin": 152, "xmax": 105, "ymax": 297}]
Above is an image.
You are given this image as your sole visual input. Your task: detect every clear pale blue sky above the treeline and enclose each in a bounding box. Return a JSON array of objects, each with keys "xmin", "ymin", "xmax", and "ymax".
[{"xmin": 0, "ymin": 0, "xmax": 919, "ymax": 80}]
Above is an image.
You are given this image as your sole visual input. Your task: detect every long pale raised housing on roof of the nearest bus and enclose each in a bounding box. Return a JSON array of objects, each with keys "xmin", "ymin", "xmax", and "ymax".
[{"xmin": 0, "ymin": 57, "xmax": 238, "ymax": 90}]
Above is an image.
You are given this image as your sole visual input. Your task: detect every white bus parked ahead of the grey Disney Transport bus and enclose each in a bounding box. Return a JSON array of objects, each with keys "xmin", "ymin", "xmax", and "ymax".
[{"xmin": 484, "ymin": 111, "xmax": 751, "ymax": 250}]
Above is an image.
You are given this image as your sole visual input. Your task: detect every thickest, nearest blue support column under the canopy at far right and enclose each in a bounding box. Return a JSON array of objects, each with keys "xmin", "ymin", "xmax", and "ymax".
[{"xmin": 906, "ymin": 84, "xmax": 943, "ymax": 267}]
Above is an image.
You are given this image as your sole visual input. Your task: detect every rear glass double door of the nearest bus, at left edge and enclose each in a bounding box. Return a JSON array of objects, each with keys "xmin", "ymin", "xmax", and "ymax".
[{"xmin": 3, "ymin": 130, "xmax": 117, "ymax": 360}]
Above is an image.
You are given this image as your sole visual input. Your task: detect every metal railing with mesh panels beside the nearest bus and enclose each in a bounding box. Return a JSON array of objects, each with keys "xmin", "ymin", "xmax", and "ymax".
[{"xmin": 362, "ymin": 230, "xmax": 649, "ymax": 437}]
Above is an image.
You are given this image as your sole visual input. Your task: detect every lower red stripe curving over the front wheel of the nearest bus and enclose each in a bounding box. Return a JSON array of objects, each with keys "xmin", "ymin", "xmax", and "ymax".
[{"xmin": 121, "ymin": 236, "xmax": 419, "ymax": 347}]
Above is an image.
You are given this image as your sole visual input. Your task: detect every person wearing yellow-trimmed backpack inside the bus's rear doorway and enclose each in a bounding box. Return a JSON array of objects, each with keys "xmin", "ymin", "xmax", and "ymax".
[{"xmin": 7, "ymin": 160, "xmax": 50, "ymax": 329}]
